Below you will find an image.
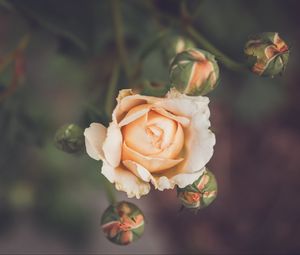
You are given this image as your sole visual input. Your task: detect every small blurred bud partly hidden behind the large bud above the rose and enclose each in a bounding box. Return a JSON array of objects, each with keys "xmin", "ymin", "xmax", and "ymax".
[{"xmin": 163, "ymin": 35, "xmax": 196, "ymax": 64}]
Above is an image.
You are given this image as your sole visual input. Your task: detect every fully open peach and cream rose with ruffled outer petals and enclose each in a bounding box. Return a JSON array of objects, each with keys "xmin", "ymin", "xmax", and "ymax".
[{"xmin": 84, "ymin": 89, "xmax": 215, "ymax": 198}]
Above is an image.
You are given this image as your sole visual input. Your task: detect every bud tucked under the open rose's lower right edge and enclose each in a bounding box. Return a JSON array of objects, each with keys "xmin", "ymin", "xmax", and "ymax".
[{"xmin": 177, "ymin": 170, "xmax": 218, "ymax": 210}]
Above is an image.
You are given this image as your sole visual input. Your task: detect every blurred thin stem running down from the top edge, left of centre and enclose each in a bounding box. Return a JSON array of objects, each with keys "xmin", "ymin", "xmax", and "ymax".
[{"xmin": 111, "ymin": 0, "xmax": 131, "ymax": 81}]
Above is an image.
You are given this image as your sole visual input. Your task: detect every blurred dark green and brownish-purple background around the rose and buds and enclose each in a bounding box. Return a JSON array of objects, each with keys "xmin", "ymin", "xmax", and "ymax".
[{"xmin": 0, "ymin": 0, "xmax": 300, "ymax": 254}]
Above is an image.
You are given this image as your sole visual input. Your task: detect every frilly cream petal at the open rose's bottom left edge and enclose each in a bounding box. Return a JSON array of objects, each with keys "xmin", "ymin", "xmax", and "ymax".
[{"xmin": 101, "ymin": 161, "xmax": 151, "ymax": 198}]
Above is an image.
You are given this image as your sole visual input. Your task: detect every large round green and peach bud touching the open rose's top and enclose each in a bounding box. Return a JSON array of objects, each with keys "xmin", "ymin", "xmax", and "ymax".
[{"xmin": 169, "ymin": 49, "xmax": 219, "ymax": 96}]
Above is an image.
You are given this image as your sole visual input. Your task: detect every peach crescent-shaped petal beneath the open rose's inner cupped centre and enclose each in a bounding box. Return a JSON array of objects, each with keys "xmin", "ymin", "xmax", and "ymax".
[{"xmin": 122, "ymin": 143, "xmax": 183, "ymax": 173}]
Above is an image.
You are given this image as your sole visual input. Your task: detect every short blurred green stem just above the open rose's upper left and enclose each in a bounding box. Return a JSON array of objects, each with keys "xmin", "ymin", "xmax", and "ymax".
[{"xmin": 105, "ymin": 61, "xmax": 120, "ymax": 117}]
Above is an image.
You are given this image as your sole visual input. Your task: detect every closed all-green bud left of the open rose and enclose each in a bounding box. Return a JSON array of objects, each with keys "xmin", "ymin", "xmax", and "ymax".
[{"xmin": 54, "ymin": 124, "xmax": 84, "ymax": 153}]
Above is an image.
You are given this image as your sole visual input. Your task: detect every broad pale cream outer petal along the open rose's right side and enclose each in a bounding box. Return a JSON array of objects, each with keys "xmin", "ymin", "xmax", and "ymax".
[{"xmin": 157, "ymin": 90, "xmax": 216, "ymax": 172}]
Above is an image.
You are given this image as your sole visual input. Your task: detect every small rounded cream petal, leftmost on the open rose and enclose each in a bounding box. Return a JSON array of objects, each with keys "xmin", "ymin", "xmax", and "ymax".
[{"xmin": 84, "ymin": 123, "xmax": 106, "ymax": 160}]
